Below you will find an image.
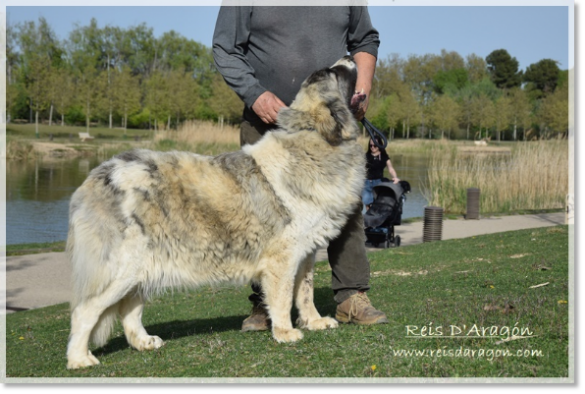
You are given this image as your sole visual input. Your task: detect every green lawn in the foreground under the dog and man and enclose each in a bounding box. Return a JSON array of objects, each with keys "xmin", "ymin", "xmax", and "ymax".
[{"xmin": 6, "ymin": 226, "xmax": 569, "ymax": 379}]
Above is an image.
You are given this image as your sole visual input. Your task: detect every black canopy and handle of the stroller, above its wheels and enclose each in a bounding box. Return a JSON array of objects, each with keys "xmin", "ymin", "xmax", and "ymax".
[{"xmin": 364, "ymin": 181, "xmax": 410, "ymax": 228}]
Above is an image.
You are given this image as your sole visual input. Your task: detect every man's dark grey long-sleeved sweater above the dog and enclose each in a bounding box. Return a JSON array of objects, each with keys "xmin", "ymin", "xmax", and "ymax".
[{"xmin": 213, "ymin": 6, "xmax": 380, "ymax": 123}]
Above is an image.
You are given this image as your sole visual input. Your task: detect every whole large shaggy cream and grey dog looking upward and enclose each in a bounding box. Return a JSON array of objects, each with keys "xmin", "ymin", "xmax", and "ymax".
[{"xmin": 67, "ymin": 57, "xmax": 365, "ymax": 368}]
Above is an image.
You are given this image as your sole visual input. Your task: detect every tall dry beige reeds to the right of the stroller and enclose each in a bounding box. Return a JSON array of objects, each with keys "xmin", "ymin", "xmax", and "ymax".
[{"xmin": 423, "ymin": 140, "xmax": 569, "ymax": 213}]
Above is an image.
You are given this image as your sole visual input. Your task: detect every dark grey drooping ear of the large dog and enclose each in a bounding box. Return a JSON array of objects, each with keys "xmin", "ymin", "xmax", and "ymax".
[{"xmin": 319, "ymin": 98, "xmax": 359, "ymax": 145}]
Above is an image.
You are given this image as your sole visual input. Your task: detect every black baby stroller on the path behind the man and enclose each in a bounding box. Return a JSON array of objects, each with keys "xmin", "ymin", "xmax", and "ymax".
[{"xmin": 364, "ymin": 178, "xmax": 410, "ymax": 248}]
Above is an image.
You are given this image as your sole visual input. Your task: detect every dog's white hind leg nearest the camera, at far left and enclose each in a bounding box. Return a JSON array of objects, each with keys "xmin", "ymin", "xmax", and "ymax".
[{"xmin": 67, "ymin": 285, "xmax": 132, "ymax": 369}]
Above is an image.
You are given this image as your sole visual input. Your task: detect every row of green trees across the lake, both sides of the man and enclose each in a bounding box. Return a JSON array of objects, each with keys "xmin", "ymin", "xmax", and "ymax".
[{"xmin": 6, "ymin": 18, "xmax": 568, "ymax": 140}]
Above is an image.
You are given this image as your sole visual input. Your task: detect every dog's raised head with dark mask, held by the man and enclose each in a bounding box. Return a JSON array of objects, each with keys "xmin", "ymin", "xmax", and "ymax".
[{"xmin": 278, "ymin": 56, "xmax": 361, "ymax": 145}]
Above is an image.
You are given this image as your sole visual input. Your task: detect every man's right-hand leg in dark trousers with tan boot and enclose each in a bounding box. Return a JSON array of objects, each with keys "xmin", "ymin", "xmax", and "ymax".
[{"xmin": 327, "ymin": 204, "xmax": 388, "ymax": 324}]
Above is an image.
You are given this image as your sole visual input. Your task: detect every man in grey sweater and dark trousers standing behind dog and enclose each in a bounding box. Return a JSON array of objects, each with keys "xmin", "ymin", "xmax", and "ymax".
[{"xmin": 213, "ymin": 7, "xmax": 388, "ymax": 331}]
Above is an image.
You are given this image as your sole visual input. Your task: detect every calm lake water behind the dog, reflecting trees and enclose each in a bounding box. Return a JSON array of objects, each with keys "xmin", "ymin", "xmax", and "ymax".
[{"xmin": 6, "ymin": 154, "xmax": 427, "ymax": 245}]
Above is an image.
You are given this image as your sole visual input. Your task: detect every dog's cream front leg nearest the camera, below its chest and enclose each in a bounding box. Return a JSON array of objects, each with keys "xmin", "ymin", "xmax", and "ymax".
[{"xmin": 262, "ymin": 253, "xmax": 303, "ymax": 342}]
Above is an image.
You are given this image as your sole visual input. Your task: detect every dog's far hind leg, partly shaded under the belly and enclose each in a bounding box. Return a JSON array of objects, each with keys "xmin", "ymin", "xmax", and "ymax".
[{"xmin": 119, "ymin": 294, "xmax": 163, "ymax": 351}]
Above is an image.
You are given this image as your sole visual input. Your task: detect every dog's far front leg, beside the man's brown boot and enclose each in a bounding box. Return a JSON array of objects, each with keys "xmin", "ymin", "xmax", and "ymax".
[{"xmin": 295, "ymin": 253, "xmax": 338, "ymax": 330}]
